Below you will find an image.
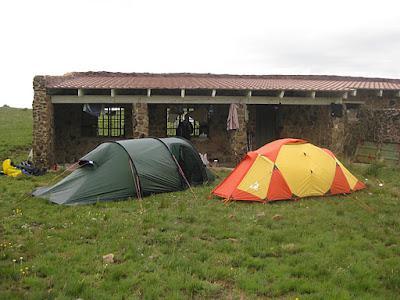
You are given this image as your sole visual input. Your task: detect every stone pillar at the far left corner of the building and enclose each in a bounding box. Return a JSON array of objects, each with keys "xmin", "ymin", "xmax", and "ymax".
[{"xmin": 32, "ymin": 76, "xmax": 54, "ymax": 167}]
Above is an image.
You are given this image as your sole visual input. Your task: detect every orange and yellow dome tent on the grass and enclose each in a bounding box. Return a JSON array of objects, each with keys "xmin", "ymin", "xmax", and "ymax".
[{"xmin": 212, "ymin": 138, "xmax": 365, "ymax": 202}]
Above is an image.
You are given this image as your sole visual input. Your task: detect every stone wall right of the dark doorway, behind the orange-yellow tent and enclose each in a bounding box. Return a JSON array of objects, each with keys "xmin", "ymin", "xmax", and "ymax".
[{"xmin": 272, "ymin": 97, "xmax": 400, "ymax": 156}]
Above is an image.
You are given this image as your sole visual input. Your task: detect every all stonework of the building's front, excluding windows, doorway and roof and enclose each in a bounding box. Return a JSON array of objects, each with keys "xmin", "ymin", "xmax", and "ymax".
[{"xmin": 33, "ymin": 87, "xmax": 400, "ymax": 166}]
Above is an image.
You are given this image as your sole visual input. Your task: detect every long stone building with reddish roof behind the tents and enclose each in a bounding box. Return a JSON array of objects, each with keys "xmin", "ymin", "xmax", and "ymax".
[{"xmin": 33, "ymin": 72, "xmax": 400, "ymax": 166}]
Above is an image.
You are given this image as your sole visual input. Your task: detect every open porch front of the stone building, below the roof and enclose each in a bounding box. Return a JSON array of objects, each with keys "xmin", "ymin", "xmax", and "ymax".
[{"xmin": 34, "ymin": 72, "xmax": 364, "ymax": 166}]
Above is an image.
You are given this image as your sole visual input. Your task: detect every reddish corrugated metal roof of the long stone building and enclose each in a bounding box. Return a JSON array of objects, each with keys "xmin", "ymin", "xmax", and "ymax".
[{"xmin": 46, "ymin": 72, "xmax": 400, "ymax": 91}]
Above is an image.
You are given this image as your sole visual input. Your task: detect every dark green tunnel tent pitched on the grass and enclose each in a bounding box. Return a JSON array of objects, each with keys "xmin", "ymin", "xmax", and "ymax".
[{"xmin": 33, "ymin": 138, "xmax": 214, "ymax": 205}]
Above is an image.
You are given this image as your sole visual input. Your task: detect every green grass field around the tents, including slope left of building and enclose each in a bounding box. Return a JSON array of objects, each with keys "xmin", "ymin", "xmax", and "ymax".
[{"xmin": 0, "ymin": 108, "xmax": 400, "ymax": 299}]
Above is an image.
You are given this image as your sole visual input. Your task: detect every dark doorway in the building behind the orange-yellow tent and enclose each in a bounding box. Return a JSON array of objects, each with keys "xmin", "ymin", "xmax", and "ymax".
[{"xmin": 255, "ymin": 105, "xmax": 279, "ymax": 148}]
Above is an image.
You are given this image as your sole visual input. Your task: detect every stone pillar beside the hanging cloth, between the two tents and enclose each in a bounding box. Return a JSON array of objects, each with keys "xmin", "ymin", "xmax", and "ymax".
[{"xmin": 228, "ymin": 104, "xmax": 247, "ymax": 164}]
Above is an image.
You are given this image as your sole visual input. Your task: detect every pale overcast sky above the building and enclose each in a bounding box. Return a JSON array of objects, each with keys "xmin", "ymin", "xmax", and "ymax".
[{"xmin": 0, "ymin": 0, "xmax": 400, "ymax": 107}]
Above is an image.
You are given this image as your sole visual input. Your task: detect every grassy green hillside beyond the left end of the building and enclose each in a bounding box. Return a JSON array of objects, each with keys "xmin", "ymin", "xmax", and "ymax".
[{"xmin": 0, "ymin": 105, "xmax": 32, "ymax": 164}]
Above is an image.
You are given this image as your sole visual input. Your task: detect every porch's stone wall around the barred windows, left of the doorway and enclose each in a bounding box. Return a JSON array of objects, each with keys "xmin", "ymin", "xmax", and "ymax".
[{"xmin": 35, "ymin": 100, "xmax": 246, "ymax": 164}]
